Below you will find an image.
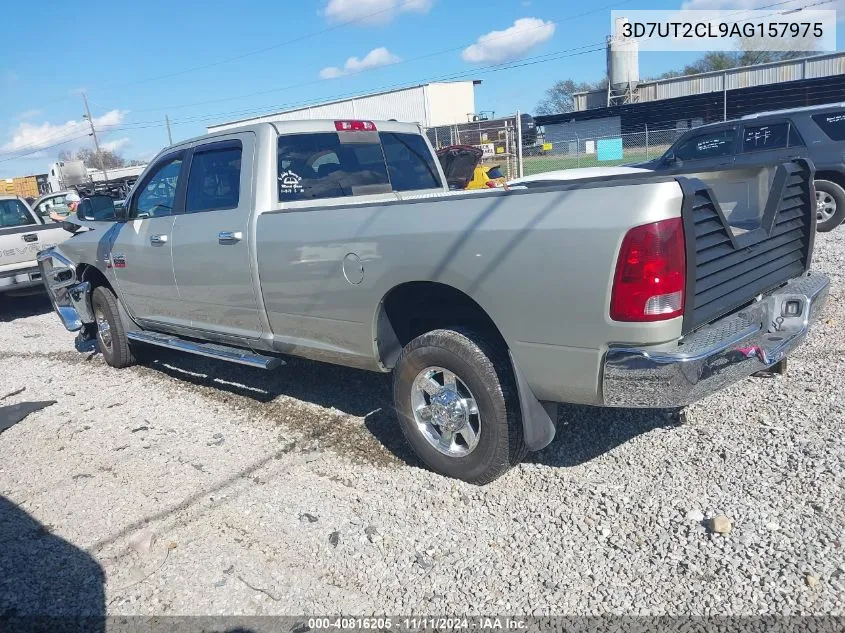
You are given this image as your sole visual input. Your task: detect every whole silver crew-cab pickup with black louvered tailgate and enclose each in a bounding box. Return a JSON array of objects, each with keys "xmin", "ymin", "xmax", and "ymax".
[{"xmin": 39, "ymin": 120, "xmax": 829, "ymax": 484}]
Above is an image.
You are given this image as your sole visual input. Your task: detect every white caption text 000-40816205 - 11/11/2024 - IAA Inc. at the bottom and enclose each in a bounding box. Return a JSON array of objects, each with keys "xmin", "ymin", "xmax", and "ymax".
[{"xmin": 308, "ymin": 616, "xmax": 528, "ymax": 631}]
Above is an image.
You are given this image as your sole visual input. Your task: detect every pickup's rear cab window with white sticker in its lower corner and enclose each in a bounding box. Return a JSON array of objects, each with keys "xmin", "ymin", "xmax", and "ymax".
[{"xmin": 278, "ymin": 122, "xmax": 441, "ymax": 202}]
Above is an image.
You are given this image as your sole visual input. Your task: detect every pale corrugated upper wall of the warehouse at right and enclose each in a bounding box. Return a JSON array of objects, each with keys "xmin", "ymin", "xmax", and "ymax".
[{"xmin": 574, "ymin": 53, "xmax": 845, "ymax": 112}]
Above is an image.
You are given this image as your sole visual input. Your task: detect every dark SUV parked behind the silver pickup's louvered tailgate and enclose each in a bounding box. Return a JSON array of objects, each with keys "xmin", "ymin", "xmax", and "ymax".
[{"xmin": 636, "ymin": 103, "xmax": 845, "ymax": 231}]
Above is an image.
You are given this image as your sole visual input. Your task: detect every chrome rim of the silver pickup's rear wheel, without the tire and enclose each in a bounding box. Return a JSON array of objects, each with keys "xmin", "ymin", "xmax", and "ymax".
[{"xmin": 411, "ymin": 367, "xmax": 481, "ymax": 457}]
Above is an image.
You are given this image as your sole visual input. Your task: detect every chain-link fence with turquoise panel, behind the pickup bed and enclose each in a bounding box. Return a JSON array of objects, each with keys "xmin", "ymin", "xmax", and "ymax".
[{"xmin": 523, "ymin": 129, "xmax": 687, "ymax": 176}]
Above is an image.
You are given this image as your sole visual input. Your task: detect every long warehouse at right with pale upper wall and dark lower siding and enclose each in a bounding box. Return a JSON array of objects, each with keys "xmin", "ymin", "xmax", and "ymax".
[{"xmin": 536, "ymin": 53, "xmax": 845, "ymax": 142}]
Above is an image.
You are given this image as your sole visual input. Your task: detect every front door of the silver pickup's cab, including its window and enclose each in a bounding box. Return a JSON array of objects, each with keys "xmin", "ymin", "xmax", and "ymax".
[{"xmin": 107, "ymin": 150, "xmax": 190, "ymax": 325}]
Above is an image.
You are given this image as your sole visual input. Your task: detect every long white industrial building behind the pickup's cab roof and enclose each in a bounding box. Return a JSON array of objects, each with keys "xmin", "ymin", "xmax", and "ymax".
[{"xmin": 208, "ymin": 80, "xmax": 481, "ymax": 132}]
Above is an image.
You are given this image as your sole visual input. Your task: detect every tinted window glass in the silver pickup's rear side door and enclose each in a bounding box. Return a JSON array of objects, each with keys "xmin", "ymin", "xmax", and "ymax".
[{"xmin": 185, "ymin": 142, "xmax": 242, "ymax": 213}]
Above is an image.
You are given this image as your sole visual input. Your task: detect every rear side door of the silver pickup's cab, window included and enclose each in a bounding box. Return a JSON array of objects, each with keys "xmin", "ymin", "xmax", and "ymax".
[{"xmin": 172, "ymin": 132, "xmax": 261, "ymax": 338}]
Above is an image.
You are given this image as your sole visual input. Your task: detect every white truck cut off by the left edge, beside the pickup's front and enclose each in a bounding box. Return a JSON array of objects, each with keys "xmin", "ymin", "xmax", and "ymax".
[{"xmin": 0, "ymin": 194, "xmax": 70, "ymax": 293}]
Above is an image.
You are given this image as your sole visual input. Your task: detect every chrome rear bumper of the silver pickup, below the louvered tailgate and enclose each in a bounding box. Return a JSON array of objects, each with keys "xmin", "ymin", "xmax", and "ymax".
[{"xmin": 602, "ymin": 273, "xmax": 830, "ymax": 408}]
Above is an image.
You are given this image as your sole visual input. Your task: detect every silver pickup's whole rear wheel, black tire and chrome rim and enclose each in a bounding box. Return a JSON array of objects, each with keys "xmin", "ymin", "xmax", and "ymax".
[{"xmin": 393, "ymin": 329, "xmax": 526, "ymax": 485}]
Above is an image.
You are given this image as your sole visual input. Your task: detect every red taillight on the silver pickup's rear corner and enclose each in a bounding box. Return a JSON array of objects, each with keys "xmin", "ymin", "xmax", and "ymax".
[{"xmin": 610, "ymin": 218, "xmax": 687, "ymax": 321}]
